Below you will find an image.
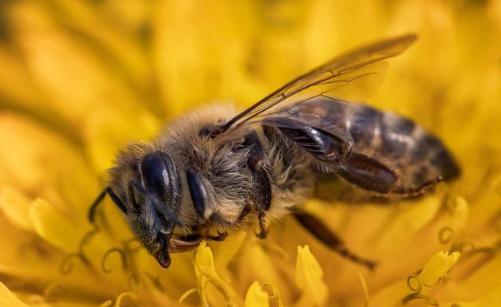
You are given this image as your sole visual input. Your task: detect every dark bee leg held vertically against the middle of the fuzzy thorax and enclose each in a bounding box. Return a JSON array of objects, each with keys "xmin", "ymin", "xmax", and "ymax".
[{"xmin": 243, "ymin": 132, "xmax": 271, "ymax": 239}]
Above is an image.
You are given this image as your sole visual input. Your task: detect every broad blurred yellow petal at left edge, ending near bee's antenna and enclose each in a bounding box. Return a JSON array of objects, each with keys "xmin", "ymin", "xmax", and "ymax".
[{"xmin": 0, "ymin": 113, "xmax": 96, "ymax": 216}]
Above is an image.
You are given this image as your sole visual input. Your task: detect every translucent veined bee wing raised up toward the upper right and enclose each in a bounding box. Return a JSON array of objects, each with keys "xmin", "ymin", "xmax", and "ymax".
[{"xmin": 220, "ymin": 34, "xmax": 417, "ymax": 133}]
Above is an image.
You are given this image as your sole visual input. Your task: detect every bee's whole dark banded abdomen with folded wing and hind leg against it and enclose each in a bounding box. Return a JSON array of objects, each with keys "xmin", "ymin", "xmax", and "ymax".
[{"xmin": 261, "ymin": 97, "xmax": 460, "ymax": 196}]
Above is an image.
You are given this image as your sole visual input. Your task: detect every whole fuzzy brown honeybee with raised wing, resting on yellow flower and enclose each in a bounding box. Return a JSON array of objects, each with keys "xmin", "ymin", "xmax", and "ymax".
[{"xmin": 89, "ymin": 34, "xmax": 460, "ymax": 268}]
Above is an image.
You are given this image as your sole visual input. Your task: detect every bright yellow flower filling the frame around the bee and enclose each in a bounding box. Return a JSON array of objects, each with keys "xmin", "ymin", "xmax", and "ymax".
[{"xmin": 0, "ymin": 0, "xmax": 501, "ymax": 307}]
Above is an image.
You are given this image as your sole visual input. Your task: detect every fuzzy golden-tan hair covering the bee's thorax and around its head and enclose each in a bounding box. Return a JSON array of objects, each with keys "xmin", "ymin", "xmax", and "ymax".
[{"xmin": 110, "ymin": 105, "xmax": 314, "ymax": 237}]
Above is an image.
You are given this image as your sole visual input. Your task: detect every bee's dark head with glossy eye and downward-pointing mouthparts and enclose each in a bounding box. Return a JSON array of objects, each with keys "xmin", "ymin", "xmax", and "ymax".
[{"xmin": 127, "ymin": 151, "xmax": 181, "ymax": 267}]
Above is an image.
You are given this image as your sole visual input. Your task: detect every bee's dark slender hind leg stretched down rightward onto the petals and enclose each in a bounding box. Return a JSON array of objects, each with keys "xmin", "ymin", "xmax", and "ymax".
[{"xmin": 292, "ymin": 209, "xmax": 377, "ymax": 270}]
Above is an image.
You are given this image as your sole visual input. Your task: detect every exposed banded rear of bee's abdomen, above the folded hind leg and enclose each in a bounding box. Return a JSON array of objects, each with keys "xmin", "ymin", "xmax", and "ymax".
[{"xmin": 345, "ymin": 104, "xmax": 460, "ymax": 187}]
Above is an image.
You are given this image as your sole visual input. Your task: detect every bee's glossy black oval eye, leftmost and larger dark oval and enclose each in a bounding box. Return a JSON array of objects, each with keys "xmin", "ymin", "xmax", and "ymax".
[{"xmin": 139, "ymin": 151, "xmax": 179, "ymax": 205}]
